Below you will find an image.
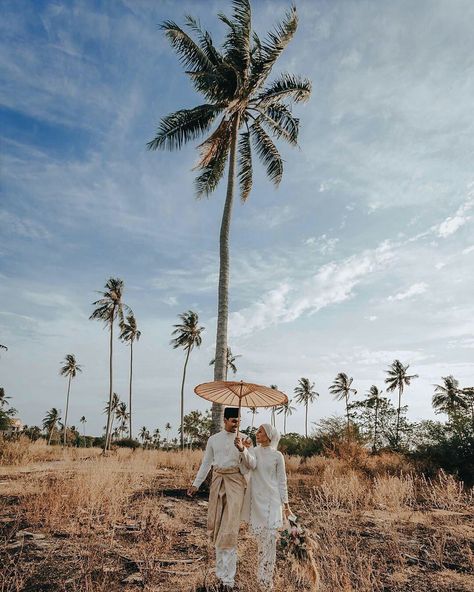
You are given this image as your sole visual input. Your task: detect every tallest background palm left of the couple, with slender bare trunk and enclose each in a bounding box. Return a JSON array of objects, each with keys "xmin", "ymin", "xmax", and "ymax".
[{"xmin": 89, "ymin": 278, "xmax": 132, "ymax": 454}]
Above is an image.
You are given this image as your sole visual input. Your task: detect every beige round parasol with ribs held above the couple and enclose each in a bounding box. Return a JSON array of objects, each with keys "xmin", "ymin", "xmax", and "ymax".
[{"xmin": 194, "ymin": 380, "xmax": 288, "ymax": 434}]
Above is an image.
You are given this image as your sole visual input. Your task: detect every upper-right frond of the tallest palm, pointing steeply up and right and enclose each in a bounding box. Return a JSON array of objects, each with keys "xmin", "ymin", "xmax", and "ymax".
[{"xmin": 249, "ymin": 6, "xmax": 298, "ymax": 90}]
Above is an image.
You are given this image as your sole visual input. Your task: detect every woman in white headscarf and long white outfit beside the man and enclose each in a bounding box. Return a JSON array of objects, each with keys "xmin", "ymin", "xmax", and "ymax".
[{"xmin": 236, "ymin": 423, "xmax": 291, "ymax": 590}]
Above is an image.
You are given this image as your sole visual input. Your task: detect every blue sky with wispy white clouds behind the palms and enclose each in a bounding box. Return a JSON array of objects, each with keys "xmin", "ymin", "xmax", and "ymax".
[{"xmin": 0, "ymin": 0, "xmax": 474, "ymax": 435}]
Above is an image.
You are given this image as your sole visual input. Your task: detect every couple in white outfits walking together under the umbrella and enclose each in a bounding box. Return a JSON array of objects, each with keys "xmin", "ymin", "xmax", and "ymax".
[{"xmin": 188, "ymin": 407, "xmax": 291, "ymax": 591}]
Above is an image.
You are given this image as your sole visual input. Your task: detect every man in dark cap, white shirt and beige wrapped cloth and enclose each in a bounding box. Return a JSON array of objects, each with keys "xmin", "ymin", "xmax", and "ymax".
[{"xmin": 188, "ymin": 407, "xmax": 255, "ymax": 590}]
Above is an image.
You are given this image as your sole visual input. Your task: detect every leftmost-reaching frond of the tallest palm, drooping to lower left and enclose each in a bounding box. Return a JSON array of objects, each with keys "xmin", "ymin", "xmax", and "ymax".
[{"xmin": 147, "ymin": 104, "xmax": 222, "ymax": 150}]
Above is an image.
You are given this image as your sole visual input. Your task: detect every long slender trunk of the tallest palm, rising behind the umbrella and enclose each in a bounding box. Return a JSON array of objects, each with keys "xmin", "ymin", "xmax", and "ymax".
[{"xmin": 211, "ymin": 113, "xmax": 240, "ymax": 434}]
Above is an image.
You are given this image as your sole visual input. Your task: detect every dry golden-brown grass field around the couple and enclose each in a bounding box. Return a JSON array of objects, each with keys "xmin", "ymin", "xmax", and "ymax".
[{"xmin": 0, "ymin": 441, "xmax": 474, "ymax": 592}]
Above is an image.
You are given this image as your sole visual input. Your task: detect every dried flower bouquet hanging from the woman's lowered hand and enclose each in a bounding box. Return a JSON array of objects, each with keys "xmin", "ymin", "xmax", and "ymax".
[{"xmin": 278, "ymin": 515, "xmax": 319, "ymax": 592}]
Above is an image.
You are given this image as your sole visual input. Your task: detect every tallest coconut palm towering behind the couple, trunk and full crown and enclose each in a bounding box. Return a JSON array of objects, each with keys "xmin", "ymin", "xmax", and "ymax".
[{"xmin": 148, "ymin": 0, "xmax": 311, "ymax": 433}]
